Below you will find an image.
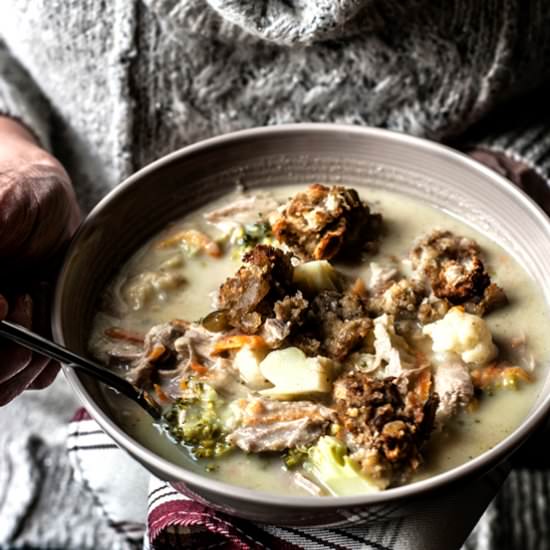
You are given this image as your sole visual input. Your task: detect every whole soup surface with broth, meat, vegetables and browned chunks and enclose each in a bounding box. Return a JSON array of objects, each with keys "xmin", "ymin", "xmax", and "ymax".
[{"xmin": 90, "ymin": 186, "xmax": 550, "ymax": 495}]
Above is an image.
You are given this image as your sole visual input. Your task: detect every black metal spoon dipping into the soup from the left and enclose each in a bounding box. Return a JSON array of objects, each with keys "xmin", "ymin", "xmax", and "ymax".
[{"xmin": 0, "ymin": 321, "xmax": 162, "ymax": 420}]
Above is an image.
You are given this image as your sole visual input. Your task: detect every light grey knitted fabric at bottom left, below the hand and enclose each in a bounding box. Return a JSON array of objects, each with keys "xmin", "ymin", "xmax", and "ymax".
[{"xmin": 0, "ymin": 377, "xmax": 132, "ymax": 550}]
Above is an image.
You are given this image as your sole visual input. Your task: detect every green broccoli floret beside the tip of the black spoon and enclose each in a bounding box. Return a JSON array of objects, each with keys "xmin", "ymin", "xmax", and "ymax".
[{"xmin": 165, "ymin": 381, "xmax": 232, "ymax": 458}]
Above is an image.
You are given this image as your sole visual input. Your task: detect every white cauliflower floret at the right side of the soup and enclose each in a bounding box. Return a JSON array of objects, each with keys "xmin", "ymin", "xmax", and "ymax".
[{"xmin": 422, "ymin": 307, "xmax": 498, "ymax": 365}]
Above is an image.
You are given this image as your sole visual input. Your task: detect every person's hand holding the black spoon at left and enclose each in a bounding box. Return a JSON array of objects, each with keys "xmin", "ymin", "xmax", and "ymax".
[{"xmin": 0, "ymin": 117, "xmax": 80, "ymax": 405}]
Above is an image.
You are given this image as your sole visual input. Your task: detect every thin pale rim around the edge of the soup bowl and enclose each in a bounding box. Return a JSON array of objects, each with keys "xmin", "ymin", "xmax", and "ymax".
[{"xmin": 51, "ymin": 123, "xmax": 550, "ymax": 510}]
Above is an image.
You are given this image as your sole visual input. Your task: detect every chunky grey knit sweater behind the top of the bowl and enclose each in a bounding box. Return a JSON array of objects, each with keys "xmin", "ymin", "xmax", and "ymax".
[{"xmin": 0, "ymin": 0, "xmax": 550, "ymax": 209}]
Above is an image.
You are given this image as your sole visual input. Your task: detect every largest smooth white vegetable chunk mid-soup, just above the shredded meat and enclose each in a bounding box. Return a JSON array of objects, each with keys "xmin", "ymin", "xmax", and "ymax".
[{"xmin": 260, "ymin": 347, "xmax": 335, "ymax": 399}]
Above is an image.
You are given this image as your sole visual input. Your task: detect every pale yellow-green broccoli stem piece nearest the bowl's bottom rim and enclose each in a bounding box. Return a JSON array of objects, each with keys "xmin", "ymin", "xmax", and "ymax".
[{"xmin": 304, "ymin": 435, "xmax": 380, "ymax": 496}]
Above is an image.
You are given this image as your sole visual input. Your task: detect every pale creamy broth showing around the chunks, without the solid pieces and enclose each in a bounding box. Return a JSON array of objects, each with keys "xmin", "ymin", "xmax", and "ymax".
[{"xmin": 91, "ymin": 186, "xmax": 550, "ymax": 495}]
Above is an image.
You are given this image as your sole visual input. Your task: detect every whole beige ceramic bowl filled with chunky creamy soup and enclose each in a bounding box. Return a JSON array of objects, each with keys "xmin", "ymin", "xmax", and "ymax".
[{"xmin": 53, "ymin": 124, "xmax": 550, "ymax": 525}]
